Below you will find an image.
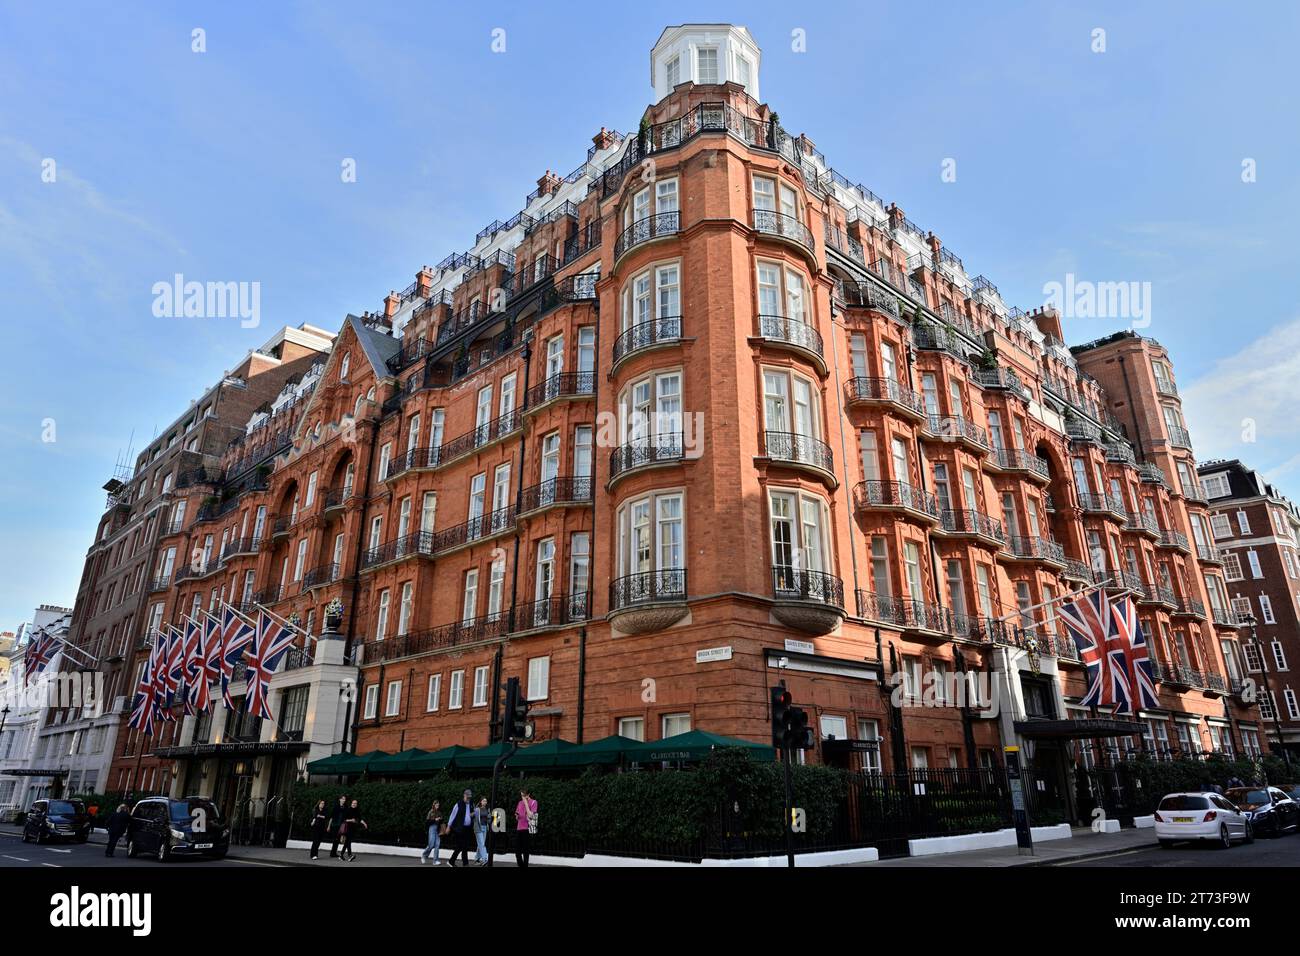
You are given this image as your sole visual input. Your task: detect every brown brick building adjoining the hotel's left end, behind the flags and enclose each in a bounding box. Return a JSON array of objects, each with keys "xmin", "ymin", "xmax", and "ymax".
[{"xmin": 50, "ymin": 325, "xmax": 333, "ymax": 791}]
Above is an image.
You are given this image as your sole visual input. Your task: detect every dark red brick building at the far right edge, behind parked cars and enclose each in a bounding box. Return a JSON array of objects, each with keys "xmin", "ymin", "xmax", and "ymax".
[{"xmin": 1200, "ymin": 459, "xmax": 1300, "ymax": 752}]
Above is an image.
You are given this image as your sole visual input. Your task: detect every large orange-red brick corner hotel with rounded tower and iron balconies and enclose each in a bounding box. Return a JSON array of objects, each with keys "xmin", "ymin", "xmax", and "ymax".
[{"xmin": 65, "ymin": 25, "xmax": 1258, "ymax": 816}]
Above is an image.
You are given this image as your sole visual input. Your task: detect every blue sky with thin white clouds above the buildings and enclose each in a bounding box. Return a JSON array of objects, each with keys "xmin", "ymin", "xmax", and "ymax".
[{"xmin": 0, "ymin": 3, "xmax": 1300, "ymax": 630}]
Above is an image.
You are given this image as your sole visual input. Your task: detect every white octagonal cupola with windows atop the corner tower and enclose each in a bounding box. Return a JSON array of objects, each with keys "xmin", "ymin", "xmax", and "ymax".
[{"xmin": 650, "ymin": 23, "xmax": 763, "ymax": 103}]
